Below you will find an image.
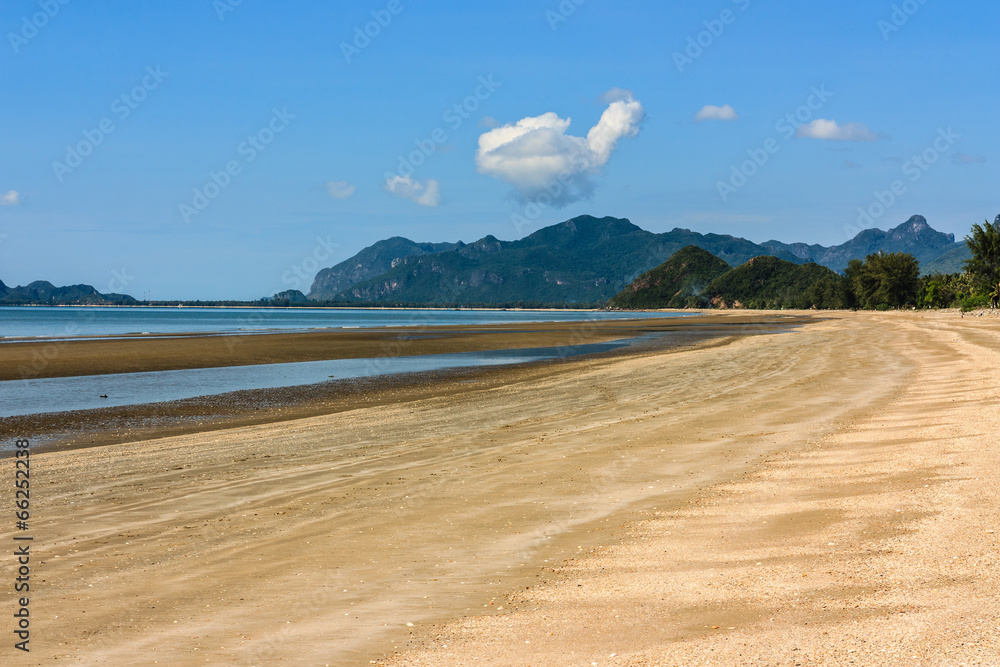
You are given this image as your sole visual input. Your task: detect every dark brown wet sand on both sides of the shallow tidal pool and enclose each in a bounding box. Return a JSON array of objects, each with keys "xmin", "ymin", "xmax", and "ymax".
[{"xmin": 0, "ymin": 314, "xmax": 804, "ymax": 458}]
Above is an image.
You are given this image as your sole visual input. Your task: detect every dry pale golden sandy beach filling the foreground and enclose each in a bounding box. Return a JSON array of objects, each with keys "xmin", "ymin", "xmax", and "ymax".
[{"xmin": 0, "ymin": 312, "xmax": 1000, "ymax": 667}]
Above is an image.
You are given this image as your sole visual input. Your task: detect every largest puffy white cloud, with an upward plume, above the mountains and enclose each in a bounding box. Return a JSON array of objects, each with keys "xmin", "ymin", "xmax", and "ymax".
[{"xmin": 476, "ymin": 89, "xmax": 645, "ymax": 206}]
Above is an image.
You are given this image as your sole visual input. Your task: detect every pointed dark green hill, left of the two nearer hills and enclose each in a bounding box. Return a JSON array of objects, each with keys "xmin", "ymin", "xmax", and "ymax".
[{"xmin": 608, "ymin": 245, "xmax": 732, "ymax": 309}]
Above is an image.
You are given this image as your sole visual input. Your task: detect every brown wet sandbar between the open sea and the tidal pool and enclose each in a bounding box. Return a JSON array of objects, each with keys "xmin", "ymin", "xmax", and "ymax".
[{"xmin": 0, "ymin": 313, "xmax": 768, "ymax": 381}]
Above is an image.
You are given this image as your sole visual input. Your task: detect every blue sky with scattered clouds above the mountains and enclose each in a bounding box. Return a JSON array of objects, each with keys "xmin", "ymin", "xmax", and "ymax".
[{"xmin": 0, "ymin": 0, "xmax": 1000, "ymax": 299}]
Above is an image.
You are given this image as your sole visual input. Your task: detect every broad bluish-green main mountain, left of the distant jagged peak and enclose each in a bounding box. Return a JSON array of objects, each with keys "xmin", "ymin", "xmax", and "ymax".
[{"xmin": 309, "ymin": 216, "xmax": 796, "ymax": 303}]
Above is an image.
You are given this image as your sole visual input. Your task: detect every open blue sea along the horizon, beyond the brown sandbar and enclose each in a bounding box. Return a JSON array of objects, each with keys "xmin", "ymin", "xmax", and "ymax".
[{"xmin": 0, "ymin": 306, "xmax": 684, "ymax": 338}]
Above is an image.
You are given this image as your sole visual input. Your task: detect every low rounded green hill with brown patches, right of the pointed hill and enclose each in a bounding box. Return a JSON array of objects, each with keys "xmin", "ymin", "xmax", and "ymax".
[{"xmin": 702, "ymin": 256, "xmax": 844, "ymax": 308}]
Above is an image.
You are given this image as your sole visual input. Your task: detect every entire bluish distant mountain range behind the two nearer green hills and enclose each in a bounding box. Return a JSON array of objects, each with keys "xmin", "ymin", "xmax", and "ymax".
[{"xmin": 308, "ymin": 215, "xmax": 968, "ymax": 304}]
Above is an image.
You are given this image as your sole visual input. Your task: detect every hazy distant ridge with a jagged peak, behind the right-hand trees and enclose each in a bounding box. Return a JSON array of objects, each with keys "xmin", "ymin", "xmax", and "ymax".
[{"xmin": 761, "ymin": 215, "xmax": 965, "ymax": 273}]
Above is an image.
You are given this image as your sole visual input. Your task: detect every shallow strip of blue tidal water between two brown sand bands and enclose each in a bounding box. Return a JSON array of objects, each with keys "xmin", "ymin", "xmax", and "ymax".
[{"xmin": 0, "ymin": 339, "xmax": 634, "ymax": 417}]
